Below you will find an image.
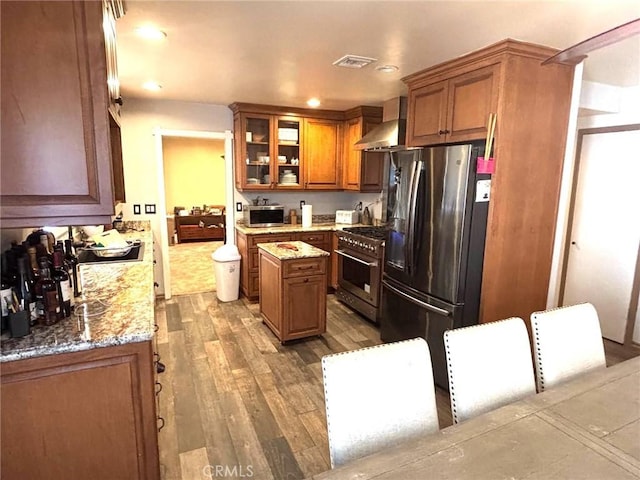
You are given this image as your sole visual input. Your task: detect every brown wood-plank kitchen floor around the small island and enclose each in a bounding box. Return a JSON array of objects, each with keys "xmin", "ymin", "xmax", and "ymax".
[{"xmin": 156, "ymin": 292, "xmax": 638, "ymax": 480}]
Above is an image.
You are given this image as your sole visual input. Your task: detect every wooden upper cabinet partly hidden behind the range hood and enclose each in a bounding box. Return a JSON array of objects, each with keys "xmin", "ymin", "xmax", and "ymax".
[{"xmin": 342, "ymin": 107, "xmax": 384, "ymax": 192}]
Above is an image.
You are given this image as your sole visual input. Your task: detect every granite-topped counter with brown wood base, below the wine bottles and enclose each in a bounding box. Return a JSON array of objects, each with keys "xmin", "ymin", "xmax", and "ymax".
[{"xmin": 0, "ymin": 225, "xmax": 160, "ymax": 480}]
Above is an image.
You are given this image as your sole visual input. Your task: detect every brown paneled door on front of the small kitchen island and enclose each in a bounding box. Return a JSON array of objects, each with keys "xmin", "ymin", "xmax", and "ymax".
[{"xmin": 283, "ymin": 275, "xmax": 327, "ymax": 340}]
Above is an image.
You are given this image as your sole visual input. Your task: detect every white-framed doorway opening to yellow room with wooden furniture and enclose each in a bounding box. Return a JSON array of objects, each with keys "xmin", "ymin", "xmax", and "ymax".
[{"xmin": 156, "ymin": 129, "xmax": 233, "ymax": 299}]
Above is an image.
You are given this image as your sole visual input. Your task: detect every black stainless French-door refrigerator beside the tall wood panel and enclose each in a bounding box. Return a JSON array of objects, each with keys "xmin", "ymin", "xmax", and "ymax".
[{"xmin": 380, "ymin": 143, "xmax": 490, "ymax": 388}]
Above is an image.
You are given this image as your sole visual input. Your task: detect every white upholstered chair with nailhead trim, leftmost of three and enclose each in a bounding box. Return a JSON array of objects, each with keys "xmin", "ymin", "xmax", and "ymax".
[{"xmin": 322, "ymin": 338, "xmax": 440, "ymax": 468}]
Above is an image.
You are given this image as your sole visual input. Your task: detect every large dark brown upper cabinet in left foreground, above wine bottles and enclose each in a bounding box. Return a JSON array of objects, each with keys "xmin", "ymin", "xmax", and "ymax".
[{"xmin": 0, "ymin": 1, "xmax": 125, "ymax": 228}]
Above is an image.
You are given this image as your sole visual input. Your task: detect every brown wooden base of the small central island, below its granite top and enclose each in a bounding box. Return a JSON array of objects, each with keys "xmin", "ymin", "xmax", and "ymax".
[{"xmin": 259, "ymin": 250, "xmax": 327, "ymax": 343}]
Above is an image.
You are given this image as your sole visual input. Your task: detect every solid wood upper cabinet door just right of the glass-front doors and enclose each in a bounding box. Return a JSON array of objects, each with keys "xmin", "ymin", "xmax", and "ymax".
[{"xmin": 303, "ymin": 118, "xmax": 342, "ymax": 190}]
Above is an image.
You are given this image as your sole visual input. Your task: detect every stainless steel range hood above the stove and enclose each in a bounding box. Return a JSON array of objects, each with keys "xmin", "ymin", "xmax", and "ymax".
[{"xmin": 354, "ymin": 97, "xmax": 407, "ymax": 152}]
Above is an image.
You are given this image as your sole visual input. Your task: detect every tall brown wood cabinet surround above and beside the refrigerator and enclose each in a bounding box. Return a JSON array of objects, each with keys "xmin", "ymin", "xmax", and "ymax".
[{"xmin": 403, "ymin": 40, "xmax": 574, "ymax": 322}]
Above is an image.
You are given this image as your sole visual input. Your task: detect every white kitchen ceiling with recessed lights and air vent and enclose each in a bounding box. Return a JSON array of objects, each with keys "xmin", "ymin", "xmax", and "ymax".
[{"xmin": 117, "ymin": 0, "xmax": 640, "ymax": 109}]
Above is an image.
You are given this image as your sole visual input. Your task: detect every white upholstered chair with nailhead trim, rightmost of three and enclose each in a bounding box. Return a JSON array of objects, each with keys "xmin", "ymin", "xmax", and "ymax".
[{"xmin": 531, "ymin": 303, "xmax": 606, "ymax": 392}]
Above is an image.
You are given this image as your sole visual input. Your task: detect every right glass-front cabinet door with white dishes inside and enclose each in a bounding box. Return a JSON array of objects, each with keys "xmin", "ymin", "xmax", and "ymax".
[{"xmin": 273, "ymin": 117, "xmax": 303, "ymax": 188}]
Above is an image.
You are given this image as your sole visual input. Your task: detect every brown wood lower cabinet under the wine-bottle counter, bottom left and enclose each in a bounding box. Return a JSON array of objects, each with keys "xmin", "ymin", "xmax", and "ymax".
[{"xmin": 0, "ymin": 341, "xmax": 160, "ymax": 480}]
